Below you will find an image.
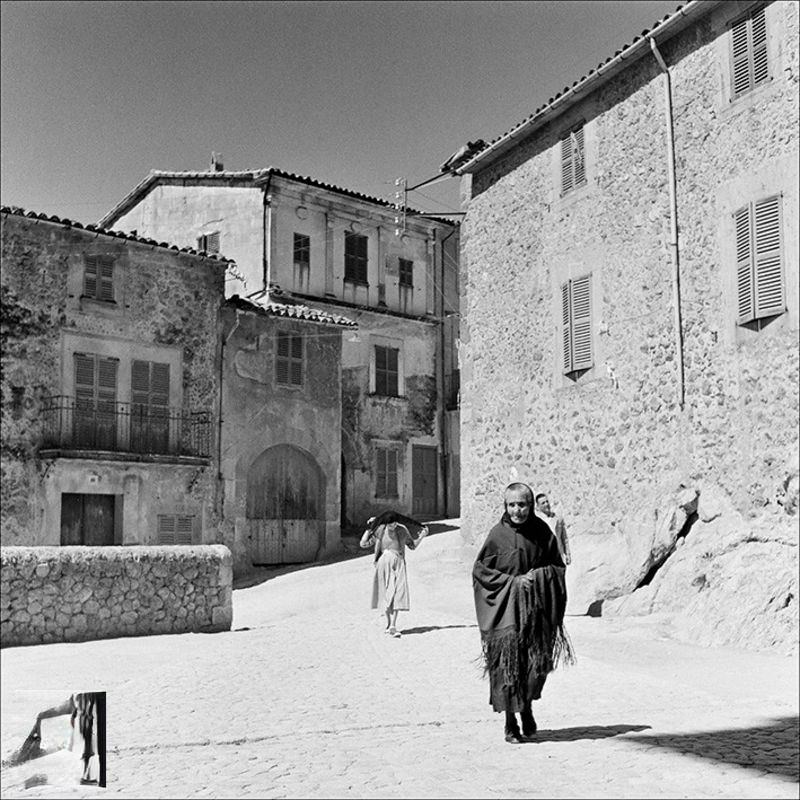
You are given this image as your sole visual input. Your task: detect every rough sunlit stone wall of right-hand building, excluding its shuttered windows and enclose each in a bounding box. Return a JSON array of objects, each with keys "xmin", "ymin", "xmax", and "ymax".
[{"xmin": 461, "ymin": 2, "xmax": 799, "ymax": 646}]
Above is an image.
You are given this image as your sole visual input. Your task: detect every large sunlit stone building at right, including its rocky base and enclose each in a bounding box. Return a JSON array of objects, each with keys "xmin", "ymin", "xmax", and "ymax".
[{"xmin": 457, "ymin": 0, "xmax": 800, "ymax": 649}]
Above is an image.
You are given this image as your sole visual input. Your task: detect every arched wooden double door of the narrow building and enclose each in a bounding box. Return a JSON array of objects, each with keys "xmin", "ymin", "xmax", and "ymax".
[{"xmin": 247, "ymin": 444, "xmax": 325, "ymax": 564}]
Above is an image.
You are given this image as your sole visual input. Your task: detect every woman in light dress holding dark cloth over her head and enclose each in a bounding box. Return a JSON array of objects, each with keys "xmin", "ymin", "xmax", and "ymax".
[{"xmin": 360, "ymin": 511, "xmax": 428, "ymax": 639}]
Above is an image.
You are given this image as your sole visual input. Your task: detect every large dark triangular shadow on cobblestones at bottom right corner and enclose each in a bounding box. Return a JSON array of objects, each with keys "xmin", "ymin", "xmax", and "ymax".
[{"xmin": 628, "ymin": 717, "xmax": 800, "ymax": 781}]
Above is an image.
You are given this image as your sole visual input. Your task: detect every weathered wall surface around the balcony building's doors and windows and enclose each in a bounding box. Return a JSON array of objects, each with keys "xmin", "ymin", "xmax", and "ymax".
[{"xmin": 0, "ymin": 214, "xmax": 224, "ymax": 545}]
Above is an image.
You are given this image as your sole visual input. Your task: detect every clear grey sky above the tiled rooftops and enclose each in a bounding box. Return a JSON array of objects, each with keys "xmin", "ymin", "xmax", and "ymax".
[{"xmin": 0, "ymin": 0, "xmax": 678, "ymax": 223}]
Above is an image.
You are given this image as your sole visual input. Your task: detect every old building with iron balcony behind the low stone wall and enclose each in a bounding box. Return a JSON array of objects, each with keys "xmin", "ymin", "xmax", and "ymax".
[{"xmin": 0, "ymin": 207, "xmax": 228, "ymax": 545}]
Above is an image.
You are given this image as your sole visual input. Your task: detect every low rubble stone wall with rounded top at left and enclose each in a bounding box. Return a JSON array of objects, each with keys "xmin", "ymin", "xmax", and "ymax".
[{"xmin": 0, "ymin": 545, "xmax": 233, "ymax": 647}]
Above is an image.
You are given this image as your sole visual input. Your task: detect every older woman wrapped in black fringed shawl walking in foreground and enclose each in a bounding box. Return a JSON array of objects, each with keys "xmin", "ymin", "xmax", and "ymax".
[{"xmin": 472, "ymin": 483, "xmax": 573, "ymax": 744}]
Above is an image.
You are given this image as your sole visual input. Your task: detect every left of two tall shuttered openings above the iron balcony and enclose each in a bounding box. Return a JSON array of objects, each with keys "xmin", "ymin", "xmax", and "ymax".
[{"xmin": 74, "ymin": 353, "xmax": 119, "ymax": 450}]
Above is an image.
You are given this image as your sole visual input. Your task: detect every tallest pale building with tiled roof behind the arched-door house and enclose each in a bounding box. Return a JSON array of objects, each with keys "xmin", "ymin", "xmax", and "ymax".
[{"xmin": 99, "ymin": 162, "xmax": 459, "ymax": 529}]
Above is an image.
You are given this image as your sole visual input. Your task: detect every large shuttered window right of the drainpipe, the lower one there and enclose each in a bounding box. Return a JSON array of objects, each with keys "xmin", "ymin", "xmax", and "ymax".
[{"xmin": 734, "ymin": 195, "xmax": 786, "ymax": 325}]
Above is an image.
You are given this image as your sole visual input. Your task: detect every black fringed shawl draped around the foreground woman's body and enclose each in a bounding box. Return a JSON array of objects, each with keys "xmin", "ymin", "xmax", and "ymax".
[{"xmin": 472, "ymin": 511, "xmax": 574, "ymax": 686}]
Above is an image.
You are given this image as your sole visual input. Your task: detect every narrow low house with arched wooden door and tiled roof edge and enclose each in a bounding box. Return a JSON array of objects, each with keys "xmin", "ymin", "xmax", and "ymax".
[{"xmin": 220, "ymin": 295, "xmax": 357, "ymax": 571}]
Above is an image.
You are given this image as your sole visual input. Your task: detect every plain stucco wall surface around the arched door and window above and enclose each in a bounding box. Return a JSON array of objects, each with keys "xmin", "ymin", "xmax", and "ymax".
[{"xmin": 222, "ymin": 306, "xmax": 347, "ymax": 571}]
